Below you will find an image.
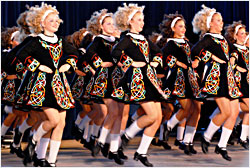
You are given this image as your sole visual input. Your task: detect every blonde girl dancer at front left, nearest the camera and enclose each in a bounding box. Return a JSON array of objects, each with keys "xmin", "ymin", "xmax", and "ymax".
[{"xmin": 18, "ymin": 3, "xmax": 78, "ymax": 166}]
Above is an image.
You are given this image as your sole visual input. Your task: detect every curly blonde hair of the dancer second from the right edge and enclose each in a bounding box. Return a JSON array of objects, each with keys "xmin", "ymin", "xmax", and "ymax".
[{"xmin": 192, "ymin": 4, "xmax": 220, "ymax": 35}]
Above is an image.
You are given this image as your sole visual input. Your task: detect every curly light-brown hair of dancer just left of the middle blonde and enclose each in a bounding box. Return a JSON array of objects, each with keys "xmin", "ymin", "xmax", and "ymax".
[{"xmin": 87, "ymin": 9, "xmax": 113, "ymax": 36}]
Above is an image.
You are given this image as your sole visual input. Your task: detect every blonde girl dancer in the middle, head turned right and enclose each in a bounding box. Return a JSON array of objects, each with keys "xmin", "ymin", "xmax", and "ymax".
[{"xmin": 112, "ymin": 4, "xmax": 165, "ymax": 166}]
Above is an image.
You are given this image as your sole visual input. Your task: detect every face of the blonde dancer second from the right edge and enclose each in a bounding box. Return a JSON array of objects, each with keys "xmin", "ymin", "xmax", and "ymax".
[{"xmin": 210, "ymin": 13, "xmax": 224, "ymax": 33}]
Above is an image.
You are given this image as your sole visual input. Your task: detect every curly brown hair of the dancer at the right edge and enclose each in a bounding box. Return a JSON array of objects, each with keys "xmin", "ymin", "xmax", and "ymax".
[{"xmin": 225, "ymin": 20, "xmax": 246, "ymax": 43}]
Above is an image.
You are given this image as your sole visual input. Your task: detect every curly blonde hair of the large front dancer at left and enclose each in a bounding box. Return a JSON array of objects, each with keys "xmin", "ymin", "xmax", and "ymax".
[{"xmin": 26, "ymin": 3, "xmax": 63, "ymax": 34}]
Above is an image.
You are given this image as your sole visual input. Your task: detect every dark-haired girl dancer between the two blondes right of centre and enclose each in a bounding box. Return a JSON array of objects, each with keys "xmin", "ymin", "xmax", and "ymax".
[{"xmin": 162, "ymin": 14, "xmax": 201, "ymax": 155}]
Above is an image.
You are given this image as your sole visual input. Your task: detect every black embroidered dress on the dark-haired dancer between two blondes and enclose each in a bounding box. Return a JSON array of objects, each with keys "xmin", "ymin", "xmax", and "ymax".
[{"xmin": 162, "ymin": 38, "xmax": 202, "ymax": 100}]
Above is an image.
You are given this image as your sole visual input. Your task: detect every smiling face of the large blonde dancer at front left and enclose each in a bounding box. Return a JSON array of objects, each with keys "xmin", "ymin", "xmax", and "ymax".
[{"xmin": 42, "ymin": 13, "xmax": 60, "ymax": 35}]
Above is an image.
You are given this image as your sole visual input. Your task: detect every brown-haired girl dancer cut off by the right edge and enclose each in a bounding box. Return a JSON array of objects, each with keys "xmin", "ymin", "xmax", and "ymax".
[{"xmin": 225, "ymin": 21, "xmax": 249, "ymax": 149}]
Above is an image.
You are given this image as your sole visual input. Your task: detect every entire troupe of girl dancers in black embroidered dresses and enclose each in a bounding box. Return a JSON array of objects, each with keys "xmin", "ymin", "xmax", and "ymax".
[{"xmin": 1, "ymin": 3, "xmax": 249, "ymax": 167}]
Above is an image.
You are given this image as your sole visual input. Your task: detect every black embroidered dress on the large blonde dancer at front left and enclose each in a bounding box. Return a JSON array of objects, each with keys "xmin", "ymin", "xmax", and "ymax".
[{"xmin": 17, "ymin": 34, "xmax": 78, "ymax": 110}]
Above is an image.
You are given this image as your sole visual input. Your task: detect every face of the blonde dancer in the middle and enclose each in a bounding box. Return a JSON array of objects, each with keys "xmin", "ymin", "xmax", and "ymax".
[{"xmin": 130, "ymin": 12, "xmax": 144, "ymax": 33}]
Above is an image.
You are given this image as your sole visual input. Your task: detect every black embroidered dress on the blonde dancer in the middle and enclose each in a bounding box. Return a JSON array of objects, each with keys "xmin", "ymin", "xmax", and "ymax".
[{"xmin": 112, "ymin": 33, "xmax": 166, "ymax": 103}]
